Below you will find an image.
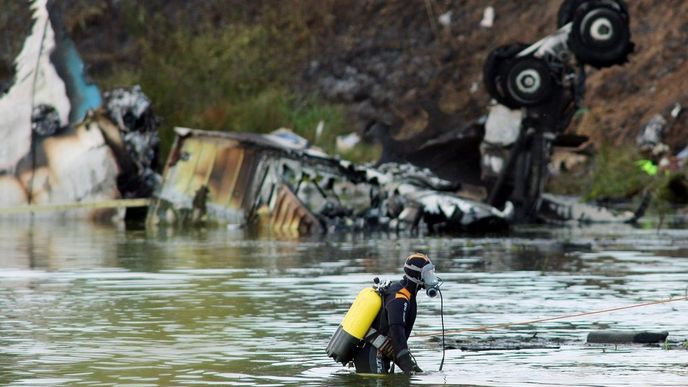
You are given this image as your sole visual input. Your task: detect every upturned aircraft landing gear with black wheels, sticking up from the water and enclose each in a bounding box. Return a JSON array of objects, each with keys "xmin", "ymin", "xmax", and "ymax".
[{"xmin": 481, "ymin": 0, "xmax": 634, "ymax": 220}]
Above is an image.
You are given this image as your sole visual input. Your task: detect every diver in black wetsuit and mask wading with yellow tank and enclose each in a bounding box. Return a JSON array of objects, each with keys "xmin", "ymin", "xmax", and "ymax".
[{"xmin": 327, "ymin": 253, "xmax": 440, "ymax": 374}]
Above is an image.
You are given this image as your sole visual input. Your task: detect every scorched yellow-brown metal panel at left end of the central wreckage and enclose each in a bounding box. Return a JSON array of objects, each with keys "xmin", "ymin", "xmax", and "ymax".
[{"xmin": 148, "ymin": 128, "xmax": 320, "ymax": 232}]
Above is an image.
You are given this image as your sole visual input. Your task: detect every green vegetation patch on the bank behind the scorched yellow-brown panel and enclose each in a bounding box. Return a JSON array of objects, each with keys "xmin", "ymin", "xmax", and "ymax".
[{"xmin": 98, "ymin": 3, "xmax": 380, "ymax": 161}]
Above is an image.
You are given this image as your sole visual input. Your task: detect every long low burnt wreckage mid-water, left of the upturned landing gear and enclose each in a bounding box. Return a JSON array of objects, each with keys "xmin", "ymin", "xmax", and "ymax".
[{"xmin": 147, "ymin": 128, "xmax": 513, "ymax": 234}]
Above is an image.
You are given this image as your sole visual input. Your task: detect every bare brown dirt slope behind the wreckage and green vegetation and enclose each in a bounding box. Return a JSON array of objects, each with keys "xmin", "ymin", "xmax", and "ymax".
[{"xmin": 5, "ymin": 0, "xmax": 688, "ymax": 155}]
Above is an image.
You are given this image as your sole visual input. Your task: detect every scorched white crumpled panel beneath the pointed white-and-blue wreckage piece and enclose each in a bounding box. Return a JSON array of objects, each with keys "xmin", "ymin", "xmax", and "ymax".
[{"xmin": 0, "ymin": 98, "xmax": 159, "ymax": 218}]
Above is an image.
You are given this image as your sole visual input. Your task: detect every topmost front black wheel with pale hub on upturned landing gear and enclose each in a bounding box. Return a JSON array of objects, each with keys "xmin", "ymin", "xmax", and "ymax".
[{"xmin": 568, "ymin": 0, "xmax": 633, "ymax": 68}]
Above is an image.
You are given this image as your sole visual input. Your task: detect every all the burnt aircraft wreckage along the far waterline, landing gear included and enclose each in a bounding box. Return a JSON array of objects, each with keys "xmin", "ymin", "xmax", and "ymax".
[{"xmin": 0, "ymin": 0, "xmax": 639, "ymax": 234}]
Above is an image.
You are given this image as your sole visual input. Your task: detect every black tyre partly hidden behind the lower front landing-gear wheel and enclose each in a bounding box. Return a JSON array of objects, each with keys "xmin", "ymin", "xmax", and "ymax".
[{"xmin": 483, "ymin": 43, "xmax": 529, "ymax": 109}]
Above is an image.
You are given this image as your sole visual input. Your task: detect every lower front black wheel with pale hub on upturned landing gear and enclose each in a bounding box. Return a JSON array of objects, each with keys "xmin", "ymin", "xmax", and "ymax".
[{"xmin": 506, "ymin": 57, "xmax": 554, "ymax": 107}]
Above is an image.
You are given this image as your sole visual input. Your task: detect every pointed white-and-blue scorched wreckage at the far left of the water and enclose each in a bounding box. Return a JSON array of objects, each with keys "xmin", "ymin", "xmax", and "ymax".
[{"xmin": 0, "ymin": 0, "xmax": 159, "ymax": 218}]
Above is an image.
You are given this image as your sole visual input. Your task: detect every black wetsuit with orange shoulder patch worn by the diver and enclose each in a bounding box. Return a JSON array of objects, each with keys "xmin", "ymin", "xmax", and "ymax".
[{"xmin": 354, "ymin": 279, "xmax": 417, "ymax": 374}]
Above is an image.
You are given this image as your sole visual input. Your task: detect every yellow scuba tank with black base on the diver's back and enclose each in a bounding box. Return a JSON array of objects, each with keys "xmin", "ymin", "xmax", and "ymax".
[{"xmin": 327, "ymin": 288, "xmax": 382, "ymax": 365}]
